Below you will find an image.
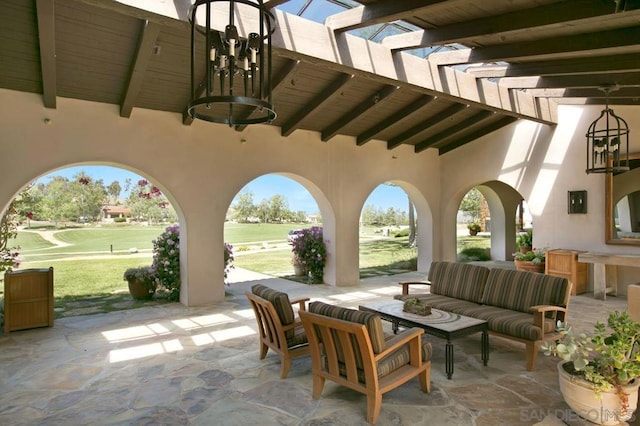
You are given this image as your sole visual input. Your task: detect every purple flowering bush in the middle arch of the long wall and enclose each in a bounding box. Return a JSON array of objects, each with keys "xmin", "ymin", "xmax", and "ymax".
[{"xmin": 291, "ymin": 226, "xmax": 327, "ymax": 282}]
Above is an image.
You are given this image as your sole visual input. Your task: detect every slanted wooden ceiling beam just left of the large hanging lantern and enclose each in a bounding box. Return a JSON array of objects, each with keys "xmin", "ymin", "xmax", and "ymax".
[{"xmin": 120, "ymin": 21, "xmax": 160, "ymax": 118}]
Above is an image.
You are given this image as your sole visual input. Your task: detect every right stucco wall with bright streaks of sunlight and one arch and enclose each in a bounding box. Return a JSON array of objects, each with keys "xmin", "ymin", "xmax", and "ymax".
[{"xmin": 440, "ymin": 106, "xmax": 640, "ymax": 293}]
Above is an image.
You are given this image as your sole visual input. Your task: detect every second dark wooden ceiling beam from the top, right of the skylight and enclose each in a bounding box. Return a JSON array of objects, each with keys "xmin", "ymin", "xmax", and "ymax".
[{"xmin": 382, "ymin": 0, "xmax": 614, "ymax": 51}]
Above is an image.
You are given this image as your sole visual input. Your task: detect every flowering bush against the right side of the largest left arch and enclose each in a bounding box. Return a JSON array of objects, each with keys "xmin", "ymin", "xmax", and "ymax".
[{"xmin": 151, "ymin": 225, "xmax": 180, "ymax": 301}]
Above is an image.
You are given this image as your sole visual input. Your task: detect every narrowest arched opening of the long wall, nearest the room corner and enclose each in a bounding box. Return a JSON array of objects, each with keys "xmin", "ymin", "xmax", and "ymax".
[{"xmin": 359, "ymin": 181, "xmax": 433, "ymax": 272}]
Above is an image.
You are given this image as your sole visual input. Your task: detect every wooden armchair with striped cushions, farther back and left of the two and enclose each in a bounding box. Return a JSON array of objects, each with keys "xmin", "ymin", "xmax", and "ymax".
[{"xmin": 245, "ymin": 284, "xmax": 309, "ymax": 379}]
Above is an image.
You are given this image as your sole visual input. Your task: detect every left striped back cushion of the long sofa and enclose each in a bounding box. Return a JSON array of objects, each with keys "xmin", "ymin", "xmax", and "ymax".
[{"xmin": 428, "ymin": 262, "xmax": 489, "ymax": 303}]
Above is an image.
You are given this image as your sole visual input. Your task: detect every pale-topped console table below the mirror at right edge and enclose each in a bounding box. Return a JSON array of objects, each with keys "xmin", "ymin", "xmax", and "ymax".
[{"xmin": 578, "ymin": 252, "xmax": 640, "ymax": 300}]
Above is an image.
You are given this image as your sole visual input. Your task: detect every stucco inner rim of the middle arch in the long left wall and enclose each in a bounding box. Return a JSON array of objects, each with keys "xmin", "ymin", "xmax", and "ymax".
[{"xmin": 221, "ymin": 171, "xmax": 337, "ymax": 285}]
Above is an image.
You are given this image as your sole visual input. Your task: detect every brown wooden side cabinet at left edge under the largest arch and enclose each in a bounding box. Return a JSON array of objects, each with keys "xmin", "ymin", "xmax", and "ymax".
[{"xmin": 4, "ymin": 268, "xmax": 53, "ymax": 333}]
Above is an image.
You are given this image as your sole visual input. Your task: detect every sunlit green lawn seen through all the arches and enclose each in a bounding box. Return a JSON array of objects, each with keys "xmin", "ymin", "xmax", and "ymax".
[{"xmin": 1, "ymin": 222, "xmax": 490, "ymax": 312}]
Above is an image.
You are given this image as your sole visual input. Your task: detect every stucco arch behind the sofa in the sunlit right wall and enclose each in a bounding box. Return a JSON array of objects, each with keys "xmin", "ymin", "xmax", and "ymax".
[{"xmin": 443, "ymin": 180, "xmax": 523, "ymax": 260}]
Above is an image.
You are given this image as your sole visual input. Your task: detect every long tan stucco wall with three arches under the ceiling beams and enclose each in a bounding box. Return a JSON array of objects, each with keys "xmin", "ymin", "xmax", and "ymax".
[{"xmin": 0, "ymin": 89, "xmax": 440, "ymax": 305}]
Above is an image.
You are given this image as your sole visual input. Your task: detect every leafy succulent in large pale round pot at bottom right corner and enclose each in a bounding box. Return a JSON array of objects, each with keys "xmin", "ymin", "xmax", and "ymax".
[{"xmin": 541, "ymin": 311, "xmax": 640, "ymax": 425}]
